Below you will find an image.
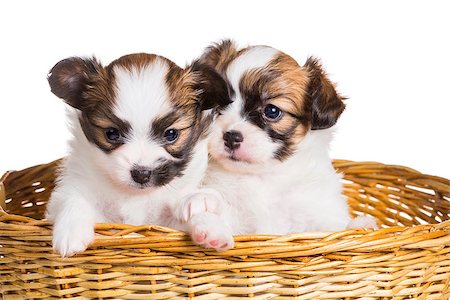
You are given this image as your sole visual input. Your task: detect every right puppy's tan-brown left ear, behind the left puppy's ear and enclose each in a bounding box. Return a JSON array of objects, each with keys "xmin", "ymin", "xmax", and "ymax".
[{"xmin": 198, "ymin": 39, "xmax": 238, "ymax": 74}]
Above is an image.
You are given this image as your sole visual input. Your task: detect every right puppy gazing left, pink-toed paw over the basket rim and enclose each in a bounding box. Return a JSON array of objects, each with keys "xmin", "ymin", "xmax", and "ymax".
[{"xmin": 179, "ymin": 40, "xmax": 376, "ymax": 250}]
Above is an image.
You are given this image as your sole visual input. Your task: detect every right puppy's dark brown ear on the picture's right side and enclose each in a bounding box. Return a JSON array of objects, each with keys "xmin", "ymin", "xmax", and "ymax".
[{"xmin": 304, "ymin": 57, "xmax": 345, "ymax": 130}]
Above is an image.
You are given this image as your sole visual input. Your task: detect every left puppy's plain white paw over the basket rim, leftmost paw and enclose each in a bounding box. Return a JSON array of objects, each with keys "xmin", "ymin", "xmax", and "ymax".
[{"xmin": 53, "ymin": 223, "xmax": 94, "ymax": 257}]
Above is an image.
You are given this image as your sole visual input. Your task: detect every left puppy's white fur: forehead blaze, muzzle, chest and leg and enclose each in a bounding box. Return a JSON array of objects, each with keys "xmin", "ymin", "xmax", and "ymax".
[{"xmin": 46, "ymin": 59, "xmax": 208, "ymax": 256}]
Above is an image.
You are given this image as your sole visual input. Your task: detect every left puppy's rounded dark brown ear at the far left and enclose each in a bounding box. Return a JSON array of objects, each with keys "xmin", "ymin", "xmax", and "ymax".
[{"xmin": 47, "ymin": 57, "xmax": 101, "ymax": 109}]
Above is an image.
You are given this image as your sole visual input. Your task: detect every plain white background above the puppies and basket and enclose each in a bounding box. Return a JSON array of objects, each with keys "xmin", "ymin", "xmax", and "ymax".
[{"xmin": 0, "ymin": 0, "xmax": 450, "ymax": 178}]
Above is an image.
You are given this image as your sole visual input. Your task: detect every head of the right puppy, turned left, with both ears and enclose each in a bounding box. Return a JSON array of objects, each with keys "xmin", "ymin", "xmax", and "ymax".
[{"xmin": 200, "ymin": 41, "xmax": 344, "ymax": 171}]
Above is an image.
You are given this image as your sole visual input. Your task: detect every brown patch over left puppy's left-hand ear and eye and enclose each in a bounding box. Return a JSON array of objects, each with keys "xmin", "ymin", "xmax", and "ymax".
[{"xmin": 48, "ymin": 57, "xmax": 130, "ymax": 153}]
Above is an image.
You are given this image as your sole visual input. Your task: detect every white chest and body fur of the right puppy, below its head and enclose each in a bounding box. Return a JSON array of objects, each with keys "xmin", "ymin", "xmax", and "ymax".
[{"xmin": 205, "ymin": 129, "xmax": 350, "ymax": 234}]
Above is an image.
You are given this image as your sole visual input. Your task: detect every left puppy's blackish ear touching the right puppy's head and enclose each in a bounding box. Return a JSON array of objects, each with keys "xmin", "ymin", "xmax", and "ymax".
[{"xmin": 190, "ymin": 61, "xmax": 231, "ymax": 110}]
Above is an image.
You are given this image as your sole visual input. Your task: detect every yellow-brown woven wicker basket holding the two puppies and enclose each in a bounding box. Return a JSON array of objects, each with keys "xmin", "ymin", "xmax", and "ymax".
[{"xmin": 0, "ymin": 160, "xmax": 450, "ymax": 299}]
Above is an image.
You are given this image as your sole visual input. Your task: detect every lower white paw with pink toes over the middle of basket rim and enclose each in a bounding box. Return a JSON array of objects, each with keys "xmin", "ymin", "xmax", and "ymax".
[{"xmin": 189, "ymin": 212, "xmax": 234, "ymax": 251}]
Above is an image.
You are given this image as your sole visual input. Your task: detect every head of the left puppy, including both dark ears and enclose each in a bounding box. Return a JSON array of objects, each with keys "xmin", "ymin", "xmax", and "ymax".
[{"xmin": 48, "ymin": 54, "xmax": 229, "ymax": 190}]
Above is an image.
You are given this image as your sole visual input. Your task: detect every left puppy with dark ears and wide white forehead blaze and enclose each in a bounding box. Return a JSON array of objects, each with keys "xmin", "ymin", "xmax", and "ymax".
[{"xmin": 46, "ymin": 53, "xmax": 229, "ymax": 256}]
